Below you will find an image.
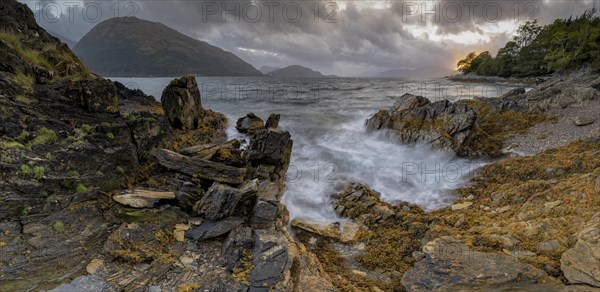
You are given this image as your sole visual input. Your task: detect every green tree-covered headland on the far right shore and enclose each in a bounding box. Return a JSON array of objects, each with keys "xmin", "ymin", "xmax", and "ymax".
[{"xmin": 457, "ymin": 5, "xmax": 600, "ymax": 77}]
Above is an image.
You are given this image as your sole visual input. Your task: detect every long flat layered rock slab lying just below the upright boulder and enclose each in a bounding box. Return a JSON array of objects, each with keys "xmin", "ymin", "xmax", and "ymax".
[{"xmin": 150, "ymin": 149, "xmax": 246, "ymax": 184}]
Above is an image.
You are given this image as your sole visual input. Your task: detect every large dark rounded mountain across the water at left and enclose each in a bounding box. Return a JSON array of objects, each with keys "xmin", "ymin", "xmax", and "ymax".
[{"xmin": 73, "ymin": 17, "xmax": 262, "ymax": 76}]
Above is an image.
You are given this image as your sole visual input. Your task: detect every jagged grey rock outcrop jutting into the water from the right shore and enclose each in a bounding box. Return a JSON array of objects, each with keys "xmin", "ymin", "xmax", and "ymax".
[{"xmin": 366, "ymin": 94, "xmax": 482, "ymax": 156}]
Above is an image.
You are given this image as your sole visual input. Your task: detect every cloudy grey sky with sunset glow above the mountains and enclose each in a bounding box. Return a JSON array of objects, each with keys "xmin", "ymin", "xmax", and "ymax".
[{"xmin": 20, "ymin": 0, "xmax": 593, "ymax": 76}]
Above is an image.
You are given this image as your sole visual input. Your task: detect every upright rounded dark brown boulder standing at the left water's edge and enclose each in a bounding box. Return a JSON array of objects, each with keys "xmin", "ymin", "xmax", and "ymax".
[{"xmin": 161, "ymin": 76, "xmax": 204, "ymax": 130}]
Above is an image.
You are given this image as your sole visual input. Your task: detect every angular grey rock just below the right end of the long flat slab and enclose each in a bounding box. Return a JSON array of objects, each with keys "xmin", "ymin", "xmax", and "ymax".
[{"xmin": 194, "ymin": 181, "xmax": 257, "ymax": 220}]
